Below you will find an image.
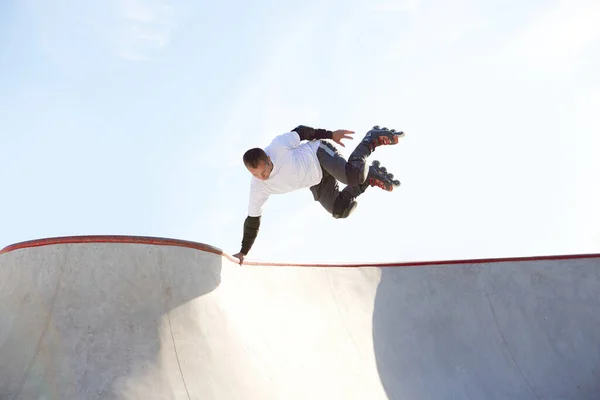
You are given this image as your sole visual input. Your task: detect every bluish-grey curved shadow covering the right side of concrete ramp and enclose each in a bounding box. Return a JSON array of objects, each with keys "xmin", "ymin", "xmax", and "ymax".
[{"xmin": 373, "ymin": 258, "xmax": 600, "ymax": 400}]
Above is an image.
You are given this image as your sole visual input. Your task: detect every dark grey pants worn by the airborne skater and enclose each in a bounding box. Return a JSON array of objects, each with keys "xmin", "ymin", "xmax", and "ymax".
[{"xmin": 310, "ymin": 141, "xmax": 368, "ymax": 218}]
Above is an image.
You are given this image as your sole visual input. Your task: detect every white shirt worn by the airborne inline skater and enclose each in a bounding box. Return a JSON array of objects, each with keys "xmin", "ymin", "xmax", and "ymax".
[{"xmin": 248, "ymin": 131, "xmax": 323, "ymax": 217}]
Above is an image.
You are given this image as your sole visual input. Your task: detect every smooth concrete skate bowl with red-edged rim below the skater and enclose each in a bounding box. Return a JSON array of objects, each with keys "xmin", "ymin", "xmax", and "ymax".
[{"xmin": 0, "ymin": 236, "xmax": 600, "ymax": 400}]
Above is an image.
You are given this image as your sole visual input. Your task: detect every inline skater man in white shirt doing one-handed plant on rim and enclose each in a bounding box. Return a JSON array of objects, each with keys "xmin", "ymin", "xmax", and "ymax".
[{"xmin": 234, "ymin": 125, "xmax": 404, "ymax": 264}]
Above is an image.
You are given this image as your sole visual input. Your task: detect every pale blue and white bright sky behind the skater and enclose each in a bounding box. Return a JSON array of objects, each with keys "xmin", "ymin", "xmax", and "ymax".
[{"xmin": 0, "ymin": 0, "xmax": 600, "ymax": 262}]
